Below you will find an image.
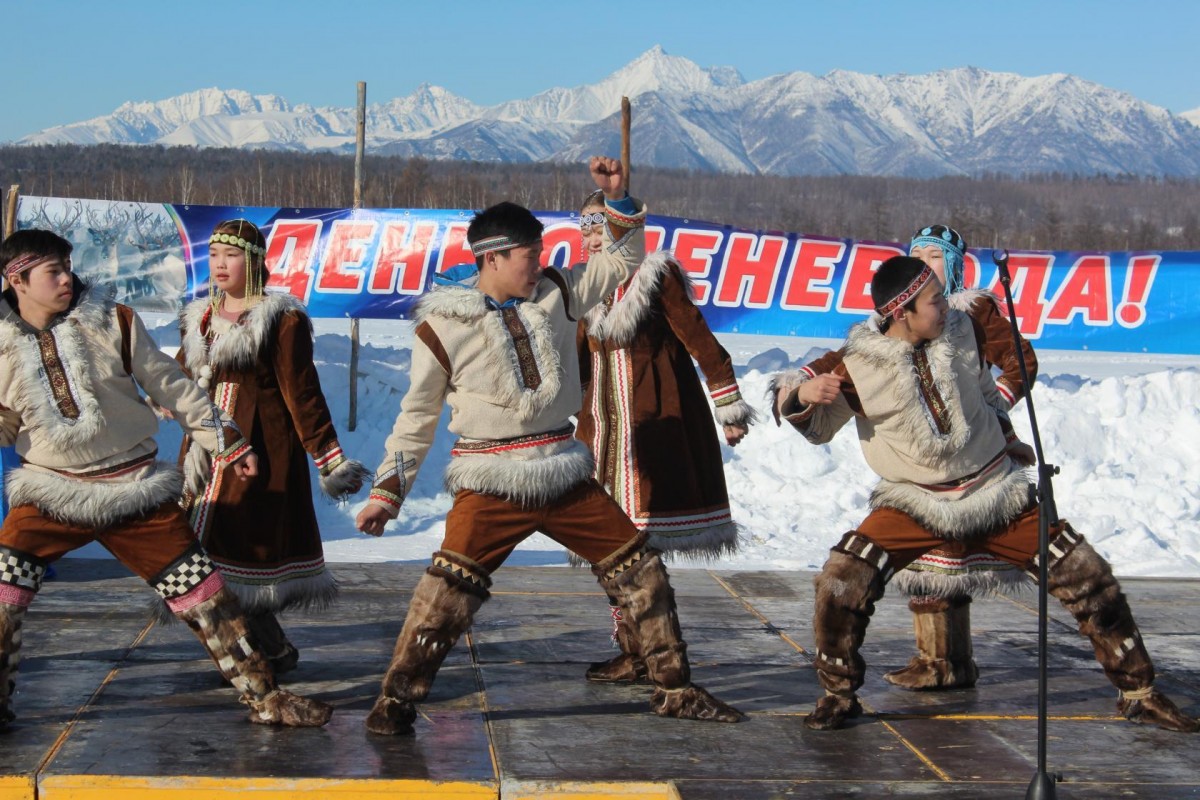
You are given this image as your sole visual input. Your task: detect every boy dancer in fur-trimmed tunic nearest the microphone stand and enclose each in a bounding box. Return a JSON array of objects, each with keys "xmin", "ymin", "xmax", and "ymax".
[{"xmin": 773, "ymin": 255, "xmax": 1200, "ymax": 732}]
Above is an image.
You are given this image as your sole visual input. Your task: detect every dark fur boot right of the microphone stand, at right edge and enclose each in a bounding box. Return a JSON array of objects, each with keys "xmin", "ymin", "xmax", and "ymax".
[{"xmin": 1028, "ymin": 523, "xmax": 1200, "ymax": 733}]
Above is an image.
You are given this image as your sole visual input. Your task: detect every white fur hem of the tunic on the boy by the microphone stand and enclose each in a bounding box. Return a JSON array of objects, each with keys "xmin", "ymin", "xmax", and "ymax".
[{"xmin": 870, "ymin": 459, "xmax": 1034, "ymax": 541}]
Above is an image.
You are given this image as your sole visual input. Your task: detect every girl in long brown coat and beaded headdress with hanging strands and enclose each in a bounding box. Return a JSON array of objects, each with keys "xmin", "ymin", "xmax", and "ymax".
[{"xmin": 179, "ymin": 219, "xmax": 370, "ymax": 672}]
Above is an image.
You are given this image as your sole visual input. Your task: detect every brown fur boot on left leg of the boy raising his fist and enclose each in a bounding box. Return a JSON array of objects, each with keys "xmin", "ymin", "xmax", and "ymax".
[{"xmin": 366, "ymin": 551, "xmax": 492, "ymax": 736}]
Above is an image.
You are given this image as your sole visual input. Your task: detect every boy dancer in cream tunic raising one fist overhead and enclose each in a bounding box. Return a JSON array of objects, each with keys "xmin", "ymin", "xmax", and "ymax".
[{"xmin": 356, "ymin": 157, "xmax": 740, "ymax": 735}]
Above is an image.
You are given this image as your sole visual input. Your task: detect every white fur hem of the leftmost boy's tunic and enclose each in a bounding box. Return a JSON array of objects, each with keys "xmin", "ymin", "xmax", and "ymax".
[{"xmin": 5, "ymin": 462, "xmax": 184, "ymax": 529}]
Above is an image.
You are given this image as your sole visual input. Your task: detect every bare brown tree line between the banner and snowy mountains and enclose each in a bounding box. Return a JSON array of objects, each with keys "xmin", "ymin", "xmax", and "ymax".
[{"xmin": 0, "ymin": 145, "xmax": 1200, "ymax": 249}]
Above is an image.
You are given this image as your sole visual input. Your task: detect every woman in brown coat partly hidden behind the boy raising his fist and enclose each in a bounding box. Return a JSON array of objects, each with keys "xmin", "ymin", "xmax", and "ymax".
[{"xmin": 576, "ymin": 193, "xmax": 755, "ymax": 682}]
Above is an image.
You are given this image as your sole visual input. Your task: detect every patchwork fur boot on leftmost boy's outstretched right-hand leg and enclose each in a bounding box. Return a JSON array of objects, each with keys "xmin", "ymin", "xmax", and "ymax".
[{"xmin": 176, "ymin": 588, "xmax": 334, "ymax": 728}]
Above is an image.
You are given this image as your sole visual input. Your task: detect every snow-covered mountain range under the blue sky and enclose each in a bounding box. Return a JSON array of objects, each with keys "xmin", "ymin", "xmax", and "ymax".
[{"xmin": 18, "ymin": 47, "xmax": 1200, "ymax": 178}]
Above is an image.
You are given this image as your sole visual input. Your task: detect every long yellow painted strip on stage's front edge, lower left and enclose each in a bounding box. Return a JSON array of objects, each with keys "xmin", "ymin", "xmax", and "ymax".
[{"xmin": 37, "ymin": 775, "xmax": 498, "ymax": 800}]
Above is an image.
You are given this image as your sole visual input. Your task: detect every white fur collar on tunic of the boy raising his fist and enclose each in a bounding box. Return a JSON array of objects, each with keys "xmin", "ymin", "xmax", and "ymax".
[{"xmin": 414, "ymin": 285, "xmax": 563, "ymax": 421}]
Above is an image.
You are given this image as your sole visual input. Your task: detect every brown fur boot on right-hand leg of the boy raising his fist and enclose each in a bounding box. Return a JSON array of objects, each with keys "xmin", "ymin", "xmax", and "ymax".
[{"xmin": 592, "ymin": 536, "xmax": 743, "ymax": 722}]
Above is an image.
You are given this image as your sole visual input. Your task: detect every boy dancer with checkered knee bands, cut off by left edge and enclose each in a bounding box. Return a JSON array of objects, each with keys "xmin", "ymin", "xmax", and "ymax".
[{"xmin": 0, "ymin": 230, "xmax": 332, "ymax": 727}]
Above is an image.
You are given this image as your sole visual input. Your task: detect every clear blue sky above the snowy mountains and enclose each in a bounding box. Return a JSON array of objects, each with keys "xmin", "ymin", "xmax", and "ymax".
[{"xmin": 0, "ymin": 0, "xmax": 1200, "ymax": 142}]
